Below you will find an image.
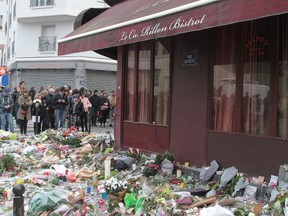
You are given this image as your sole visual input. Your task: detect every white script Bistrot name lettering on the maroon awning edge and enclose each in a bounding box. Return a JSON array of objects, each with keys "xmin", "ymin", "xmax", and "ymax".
[{"xmin": 119, "ymin": 15, "xmax": 206, "ymax": 41}]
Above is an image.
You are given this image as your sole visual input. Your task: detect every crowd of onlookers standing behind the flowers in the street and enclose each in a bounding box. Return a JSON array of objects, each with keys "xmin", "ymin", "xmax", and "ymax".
[{"xmin": 0, "ymin": 81, "xmax": 116, "ymax": 135}]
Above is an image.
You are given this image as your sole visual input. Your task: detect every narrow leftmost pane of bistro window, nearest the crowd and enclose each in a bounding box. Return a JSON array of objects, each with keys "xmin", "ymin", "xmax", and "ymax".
[{"xmin": 125, "ymin": 45, "xmax": 135, "ymax": 121}]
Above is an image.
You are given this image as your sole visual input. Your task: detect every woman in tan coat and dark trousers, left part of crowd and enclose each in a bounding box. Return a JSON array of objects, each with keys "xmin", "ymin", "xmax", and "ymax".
[{"xmin": 17, "ymin": 89, "xmax": 32, "ymax": 136}]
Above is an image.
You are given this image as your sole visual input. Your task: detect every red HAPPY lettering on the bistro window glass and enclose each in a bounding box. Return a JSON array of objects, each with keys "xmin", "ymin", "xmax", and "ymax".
[{"xmin": 245, "ymin": 36, "xmax": 269, "ymax": 57}]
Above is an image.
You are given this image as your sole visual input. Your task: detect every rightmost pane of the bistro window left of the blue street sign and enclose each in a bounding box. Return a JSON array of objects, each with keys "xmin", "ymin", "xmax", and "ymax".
[{"xmin": 152, "ymin": 39, "xmax": 170, "ymax": 125}]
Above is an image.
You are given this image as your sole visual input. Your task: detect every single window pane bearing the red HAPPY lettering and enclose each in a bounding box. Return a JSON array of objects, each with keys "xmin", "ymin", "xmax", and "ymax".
[{"xmin": 242, "ymin": 21, "xmax": 272, "ymax": 135}]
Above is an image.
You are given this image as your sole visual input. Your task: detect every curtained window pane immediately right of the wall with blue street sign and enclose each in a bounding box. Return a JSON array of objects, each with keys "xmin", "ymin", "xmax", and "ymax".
[{"xmin": 212, "ymin": 26, "xmax": 236, "ymax": 132}]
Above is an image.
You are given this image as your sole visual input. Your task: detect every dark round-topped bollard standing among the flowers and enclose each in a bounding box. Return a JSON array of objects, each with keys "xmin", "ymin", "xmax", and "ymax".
[{"xmin": 12, "ymin": 184, "xmax": 25, "ymax": 216}]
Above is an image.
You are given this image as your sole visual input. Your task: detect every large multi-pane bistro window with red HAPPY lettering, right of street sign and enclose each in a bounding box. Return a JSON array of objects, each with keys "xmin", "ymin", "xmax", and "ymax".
[{"xmin": 212, "ymin": 15, "xmax": 288, "ymax": 139}]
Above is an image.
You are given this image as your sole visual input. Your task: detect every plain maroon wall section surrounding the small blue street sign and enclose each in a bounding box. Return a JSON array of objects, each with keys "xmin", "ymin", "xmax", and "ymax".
[{"xmin": 170, "ymin": 31, "xmax": 211, "ymax": 164}]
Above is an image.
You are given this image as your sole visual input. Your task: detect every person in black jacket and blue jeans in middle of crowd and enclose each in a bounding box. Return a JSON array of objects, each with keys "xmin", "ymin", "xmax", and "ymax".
[{"xmin": 54, "ymin": 86, "xmax": 68, "ymax": 130}]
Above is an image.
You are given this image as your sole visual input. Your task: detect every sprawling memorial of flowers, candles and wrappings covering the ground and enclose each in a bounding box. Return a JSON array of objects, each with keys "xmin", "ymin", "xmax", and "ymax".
[{"xmin": 0, "ymin": 127, "xmax": 288, "ymax": 216}]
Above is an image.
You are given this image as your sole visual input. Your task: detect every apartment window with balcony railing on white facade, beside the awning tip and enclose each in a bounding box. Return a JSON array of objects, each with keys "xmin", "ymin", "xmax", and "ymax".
[{"xmin": 39, "ymin": 25, "xmax": 56, "ymax": 52}]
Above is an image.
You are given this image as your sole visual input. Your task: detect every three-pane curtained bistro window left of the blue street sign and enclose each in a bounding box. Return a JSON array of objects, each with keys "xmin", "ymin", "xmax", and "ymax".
[{"xmin": 124, "ymin": 39, "xmax": 170, "ymax": 125}]
